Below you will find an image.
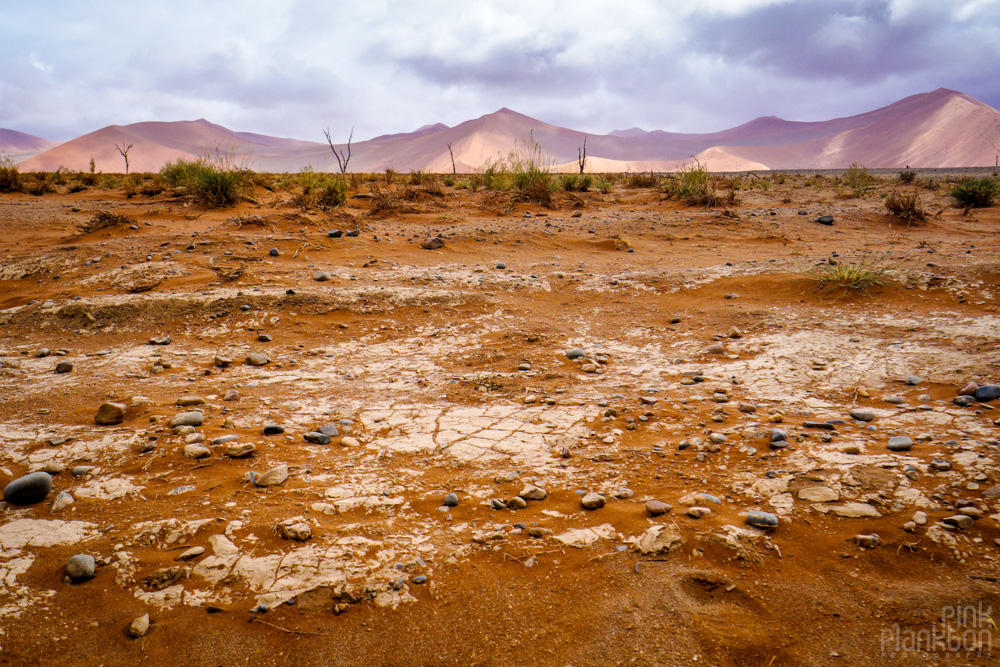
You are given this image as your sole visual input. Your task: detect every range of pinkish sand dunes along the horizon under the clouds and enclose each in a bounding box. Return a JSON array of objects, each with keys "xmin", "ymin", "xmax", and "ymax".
[{"xmin": 9, "ymin": 88, "xmax": 1000, "ymax": 172}]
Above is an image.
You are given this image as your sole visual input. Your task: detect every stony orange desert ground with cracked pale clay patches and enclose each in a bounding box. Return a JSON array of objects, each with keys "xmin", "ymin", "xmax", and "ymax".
[{"xmin": 0, "ymin": 169, "xmax": 1000, "ymax": 667}]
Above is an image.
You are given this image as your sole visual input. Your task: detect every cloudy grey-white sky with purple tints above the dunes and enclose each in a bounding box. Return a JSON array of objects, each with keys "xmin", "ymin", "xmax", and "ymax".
[{"xmin": 0, "ymin": 0, "xmax": 1000, "ymax": 141}]
